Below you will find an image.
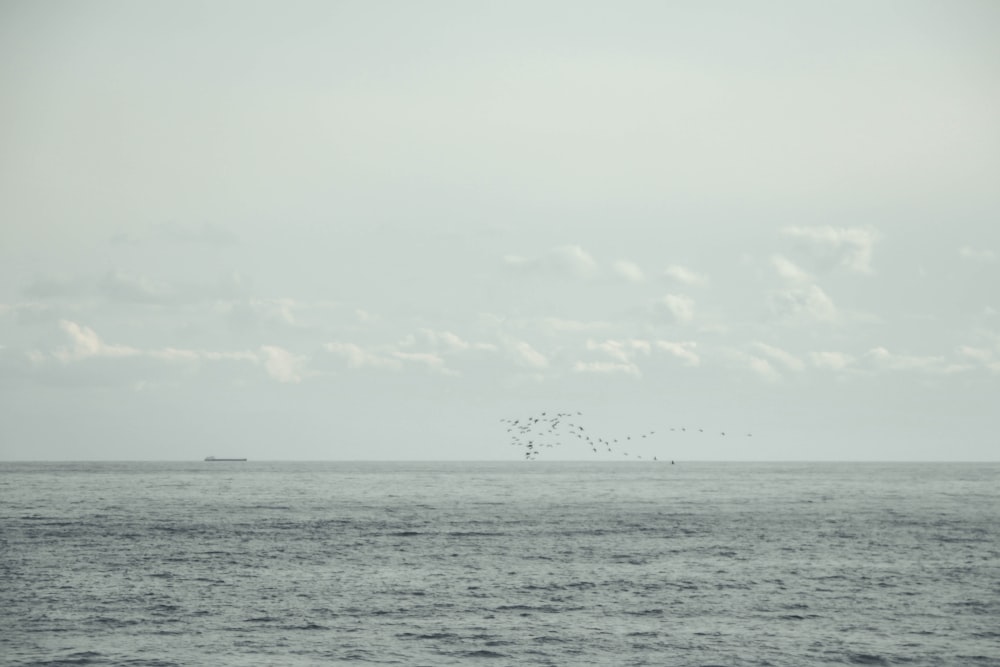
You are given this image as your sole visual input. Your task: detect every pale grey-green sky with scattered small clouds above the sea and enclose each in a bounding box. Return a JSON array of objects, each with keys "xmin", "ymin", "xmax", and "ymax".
[{"xmin": 0, "ymin": 0, "xmax": 1000, "ymax": 465}]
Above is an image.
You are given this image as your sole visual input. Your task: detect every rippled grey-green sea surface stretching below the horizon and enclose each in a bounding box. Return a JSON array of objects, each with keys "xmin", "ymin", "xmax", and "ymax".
[{"xmin": 0, "ymin": 461, "xmax": 1000, "ymax": 667}]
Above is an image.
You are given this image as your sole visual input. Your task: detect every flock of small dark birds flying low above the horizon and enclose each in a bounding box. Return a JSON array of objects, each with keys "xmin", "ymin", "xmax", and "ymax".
[{"xmin": 500, "ymin": 412, "xmax": 753, "ymax": 463}]
